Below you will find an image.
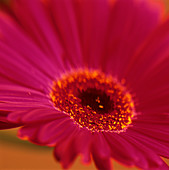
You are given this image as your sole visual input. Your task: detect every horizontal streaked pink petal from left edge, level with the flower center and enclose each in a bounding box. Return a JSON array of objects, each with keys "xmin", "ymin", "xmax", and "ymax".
[{"xmin": 0, "ymin": 85, "xmax": 53, "ymax": 111}]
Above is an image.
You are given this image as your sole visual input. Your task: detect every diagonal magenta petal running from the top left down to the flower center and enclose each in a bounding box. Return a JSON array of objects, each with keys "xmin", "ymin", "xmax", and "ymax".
[{"xmin": 12, "ymin": 0, "xmax": 64, "ymax": 69}]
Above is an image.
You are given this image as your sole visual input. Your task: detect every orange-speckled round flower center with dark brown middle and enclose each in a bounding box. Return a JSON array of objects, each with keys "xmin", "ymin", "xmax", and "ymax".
[{"xmin": 50, "ymin": 70, "xmax": 134, "ymax": 132}]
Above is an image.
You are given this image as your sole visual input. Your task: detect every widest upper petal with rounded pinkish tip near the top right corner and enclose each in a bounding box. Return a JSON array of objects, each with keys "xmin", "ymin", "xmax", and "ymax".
[{"xmin": 100, "ymin": 0, "xmax": 160, "ymax": 76}]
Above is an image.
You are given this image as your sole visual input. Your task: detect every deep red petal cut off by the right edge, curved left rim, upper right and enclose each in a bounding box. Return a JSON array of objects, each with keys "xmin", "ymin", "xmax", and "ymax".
[{"xmin": 125, "ymin": 20, "xmax": 169, "ymax": 87}]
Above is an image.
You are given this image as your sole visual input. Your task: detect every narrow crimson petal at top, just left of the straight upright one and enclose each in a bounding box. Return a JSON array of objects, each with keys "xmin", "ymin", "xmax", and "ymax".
[{"xmin": 49, "ymin": 0, "xmax": 83, "ymax": 67}]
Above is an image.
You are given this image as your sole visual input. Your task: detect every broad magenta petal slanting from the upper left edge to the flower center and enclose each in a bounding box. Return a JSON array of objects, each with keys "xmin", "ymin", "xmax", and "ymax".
[{"xmin": 0, "ymin": 15, "xmax": 61, "ymax": 89}]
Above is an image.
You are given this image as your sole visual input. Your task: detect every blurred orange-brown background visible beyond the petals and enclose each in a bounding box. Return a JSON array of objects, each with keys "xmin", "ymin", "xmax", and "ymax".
[{"xmin": 0, "ymin": 0, "xmax": 169, "ymax": 170}]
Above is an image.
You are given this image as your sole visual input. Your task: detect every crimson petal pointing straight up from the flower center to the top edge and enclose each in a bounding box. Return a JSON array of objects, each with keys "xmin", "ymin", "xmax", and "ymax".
[{"xmin": 72, "ymin": 0, "xmax": 110, "ymax": 68}]
